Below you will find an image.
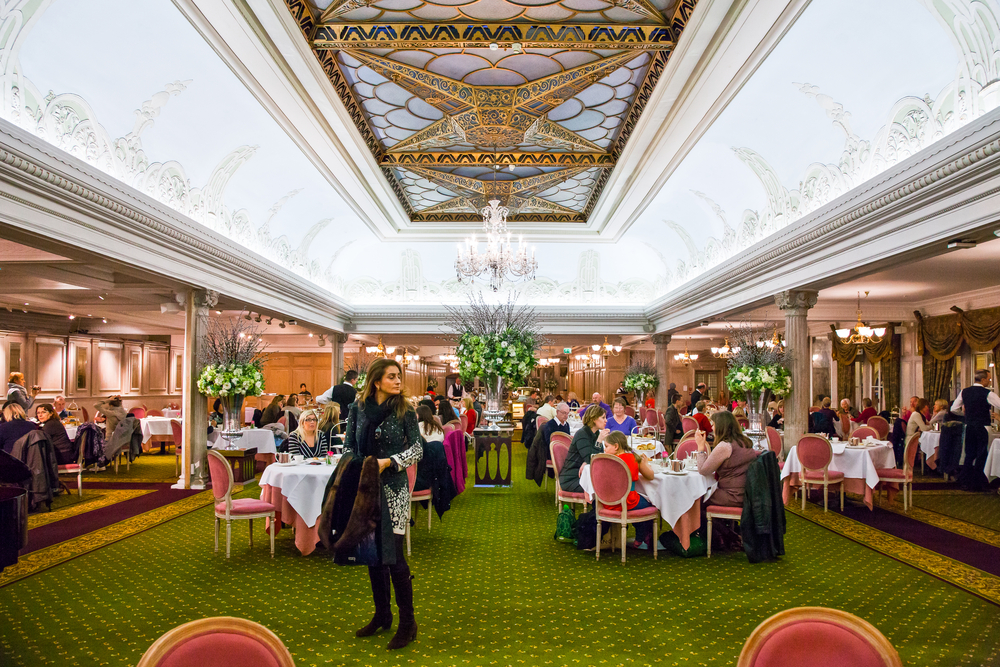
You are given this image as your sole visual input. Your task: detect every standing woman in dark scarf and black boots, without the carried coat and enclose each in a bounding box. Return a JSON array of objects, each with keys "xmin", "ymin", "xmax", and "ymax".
[{"xmin": 344, "ymin": 359, "xmax": 422, "ymax": 650}]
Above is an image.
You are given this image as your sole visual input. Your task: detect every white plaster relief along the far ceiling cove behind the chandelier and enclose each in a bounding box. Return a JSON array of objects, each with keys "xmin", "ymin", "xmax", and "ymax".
[{"xmin": 330, "ymin": 249, "xmax": 664, "ymax": 305}]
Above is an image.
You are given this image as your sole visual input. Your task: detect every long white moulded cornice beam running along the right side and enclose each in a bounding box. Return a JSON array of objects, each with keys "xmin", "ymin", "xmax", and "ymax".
[{"xmin": 647, "ymin": 110, "xmax": 1000, "ymax": 331}]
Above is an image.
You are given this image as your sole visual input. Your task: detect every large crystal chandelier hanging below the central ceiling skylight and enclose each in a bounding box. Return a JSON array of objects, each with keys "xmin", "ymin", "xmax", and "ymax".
[{"xmin": 455, "ymin": 199, "xmax": 538, "ymax": 292}]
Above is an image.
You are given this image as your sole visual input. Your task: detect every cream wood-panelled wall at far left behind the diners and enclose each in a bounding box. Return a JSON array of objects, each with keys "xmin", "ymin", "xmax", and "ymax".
[{"xmin": 0, "ymin": 332, "xmax": 184, "ymax": 413}]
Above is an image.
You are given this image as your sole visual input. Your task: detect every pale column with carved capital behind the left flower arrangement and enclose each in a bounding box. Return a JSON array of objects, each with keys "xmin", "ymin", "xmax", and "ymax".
[{"xmin": 174, "ymin": 289, "xmax": 217, "ymax": 489}]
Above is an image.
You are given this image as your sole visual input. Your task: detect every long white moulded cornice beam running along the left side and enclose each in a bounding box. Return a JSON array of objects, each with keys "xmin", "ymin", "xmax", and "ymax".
[{"xmin": 0, "ymin": 120, "xmax": 351, "ymax": 330}]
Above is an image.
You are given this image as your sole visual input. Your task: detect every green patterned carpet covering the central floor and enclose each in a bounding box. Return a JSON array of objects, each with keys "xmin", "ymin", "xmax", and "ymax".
[{"xmin": 0, "ymin": 449, "xmax": 1000, "ymax": 667}]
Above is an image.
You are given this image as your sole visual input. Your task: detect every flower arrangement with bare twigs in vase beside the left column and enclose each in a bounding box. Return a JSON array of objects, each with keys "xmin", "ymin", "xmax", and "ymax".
[{"xmin": 198, "ymin": 318, "xmax": 267, "ymax": 448}]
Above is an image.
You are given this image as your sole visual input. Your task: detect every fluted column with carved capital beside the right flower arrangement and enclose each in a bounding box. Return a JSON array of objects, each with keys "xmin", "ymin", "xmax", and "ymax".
[{"xmin": 774, "ymin": 290, "xmax": 818, "ymax": 451}]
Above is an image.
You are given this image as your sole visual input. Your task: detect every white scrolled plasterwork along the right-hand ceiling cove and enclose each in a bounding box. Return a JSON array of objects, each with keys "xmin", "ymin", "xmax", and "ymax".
[{"xmin": 650, "ymin": 0, "xmax": 1000, "ymax": 291}]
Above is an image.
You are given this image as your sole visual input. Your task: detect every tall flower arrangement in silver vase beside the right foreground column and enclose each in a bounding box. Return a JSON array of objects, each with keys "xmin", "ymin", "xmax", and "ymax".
[{"xmin": 726, "ymin": 322, "xmax": 792, "ymax": 439}]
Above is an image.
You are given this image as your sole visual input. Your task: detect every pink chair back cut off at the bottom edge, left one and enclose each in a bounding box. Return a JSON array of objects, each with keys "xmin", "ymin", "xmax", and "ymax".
[{"xmin": 138, "ymin": 616, "xmax": 295, "ymax": 667}]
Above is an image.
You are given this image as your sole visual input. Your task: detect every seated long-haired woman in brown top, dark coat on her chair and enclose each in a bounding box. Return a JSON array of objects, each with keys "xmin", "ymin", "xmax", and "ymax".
[{"xmin": 694, "ymin": 410, "xmax": 757, "ymax": 507}]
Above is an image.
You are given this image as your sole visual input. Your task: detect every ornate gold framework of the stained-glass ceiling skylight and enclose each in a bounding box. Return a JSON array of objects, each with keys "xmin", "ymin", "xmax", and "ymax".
[{"xmin": 285, "ymin": 0, "xmax": 697, "ymax": 223}]
